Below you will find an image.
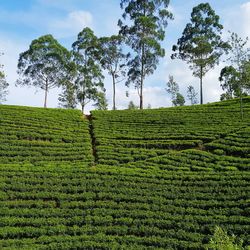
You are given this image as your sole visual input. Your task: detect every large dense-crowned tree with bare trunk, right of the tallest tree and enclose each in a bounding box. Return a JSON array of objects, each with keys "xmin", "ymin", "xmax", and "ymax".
[{"xmin": 171, "ymin": 3, "xmax": 229, "ymax": 104}]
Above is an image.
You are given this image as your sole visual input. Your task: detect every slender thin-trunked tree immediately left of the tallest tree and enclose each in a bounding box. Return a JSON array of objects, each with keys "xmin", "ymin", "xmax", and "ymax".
[{"xmin": 100, "ymin": 36, "xmax": 129, "ymax": 110}]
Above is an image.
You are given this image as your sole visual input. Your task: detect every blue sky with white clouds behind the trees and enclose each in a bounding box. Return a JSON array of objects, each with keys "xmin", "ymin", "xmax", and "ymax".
[{"xmin": 0, "ymin": 0, "xmax": 250, "ymax": 112}]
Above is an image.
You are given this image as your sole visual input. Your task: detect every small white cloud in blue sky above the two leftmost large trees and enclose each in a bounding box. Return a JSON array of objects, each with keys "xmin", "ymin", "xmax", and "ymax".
[{"xmin": 49, "ymin": 10, "xmax": 93, "ymax": 38}]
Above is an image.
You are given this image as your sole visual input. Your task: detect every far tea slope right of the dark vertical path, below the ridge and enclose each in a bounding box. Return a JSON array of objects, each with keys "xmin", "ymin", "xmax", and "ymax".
[{"xmin": 92, "ymin": 98, "xmax": 250, "ymax": 170}]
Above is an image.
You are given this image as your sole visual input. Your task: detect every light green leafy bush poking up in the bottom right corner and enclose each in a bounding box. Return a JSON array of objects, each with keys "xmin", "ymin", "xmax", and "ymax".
[{"xmin": 208, "ymin": 226, "xmax": 244, "ymax": 250}]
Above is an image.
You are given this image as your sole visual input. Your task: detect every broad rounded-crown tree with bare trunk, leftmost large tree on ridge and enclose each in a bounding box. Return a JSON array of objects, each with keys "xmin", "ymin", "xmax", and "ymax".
[{"xmin": 17, "ymin": 35, "xmax": 70, "ymax": 108}]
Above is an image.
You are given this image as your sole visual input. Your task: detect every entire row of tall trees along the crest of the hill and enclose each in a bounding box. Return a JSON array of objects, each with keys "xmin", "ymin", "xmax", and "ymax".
[{"xmin": 0, "ymin": 0, "xmax": 250, "ymax": 112}]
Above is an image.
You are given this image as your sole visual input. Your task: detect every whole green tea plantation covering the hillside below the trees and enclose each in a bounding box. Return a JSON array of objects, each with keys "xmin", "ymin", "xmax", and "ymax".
[{"xmin": 0, "ymin": 98, "xmax": 250, "ymax": 249}]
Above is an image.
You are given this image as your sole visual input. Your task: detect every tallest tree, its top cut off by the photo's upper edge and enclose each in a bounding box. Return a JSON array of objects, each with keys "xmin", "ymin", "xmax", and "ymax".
[{"xmin": 118, "ymin": 0, "xmax": 172, "ymax": 109}]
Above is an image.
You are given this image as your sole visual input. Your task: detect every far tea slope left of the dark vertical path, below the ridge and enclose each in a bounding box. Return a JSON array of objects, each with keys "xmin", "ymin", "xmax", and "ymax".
[{"xmin": 0, "ymin": 105, "xmax": 93, "ymax": 164}]
